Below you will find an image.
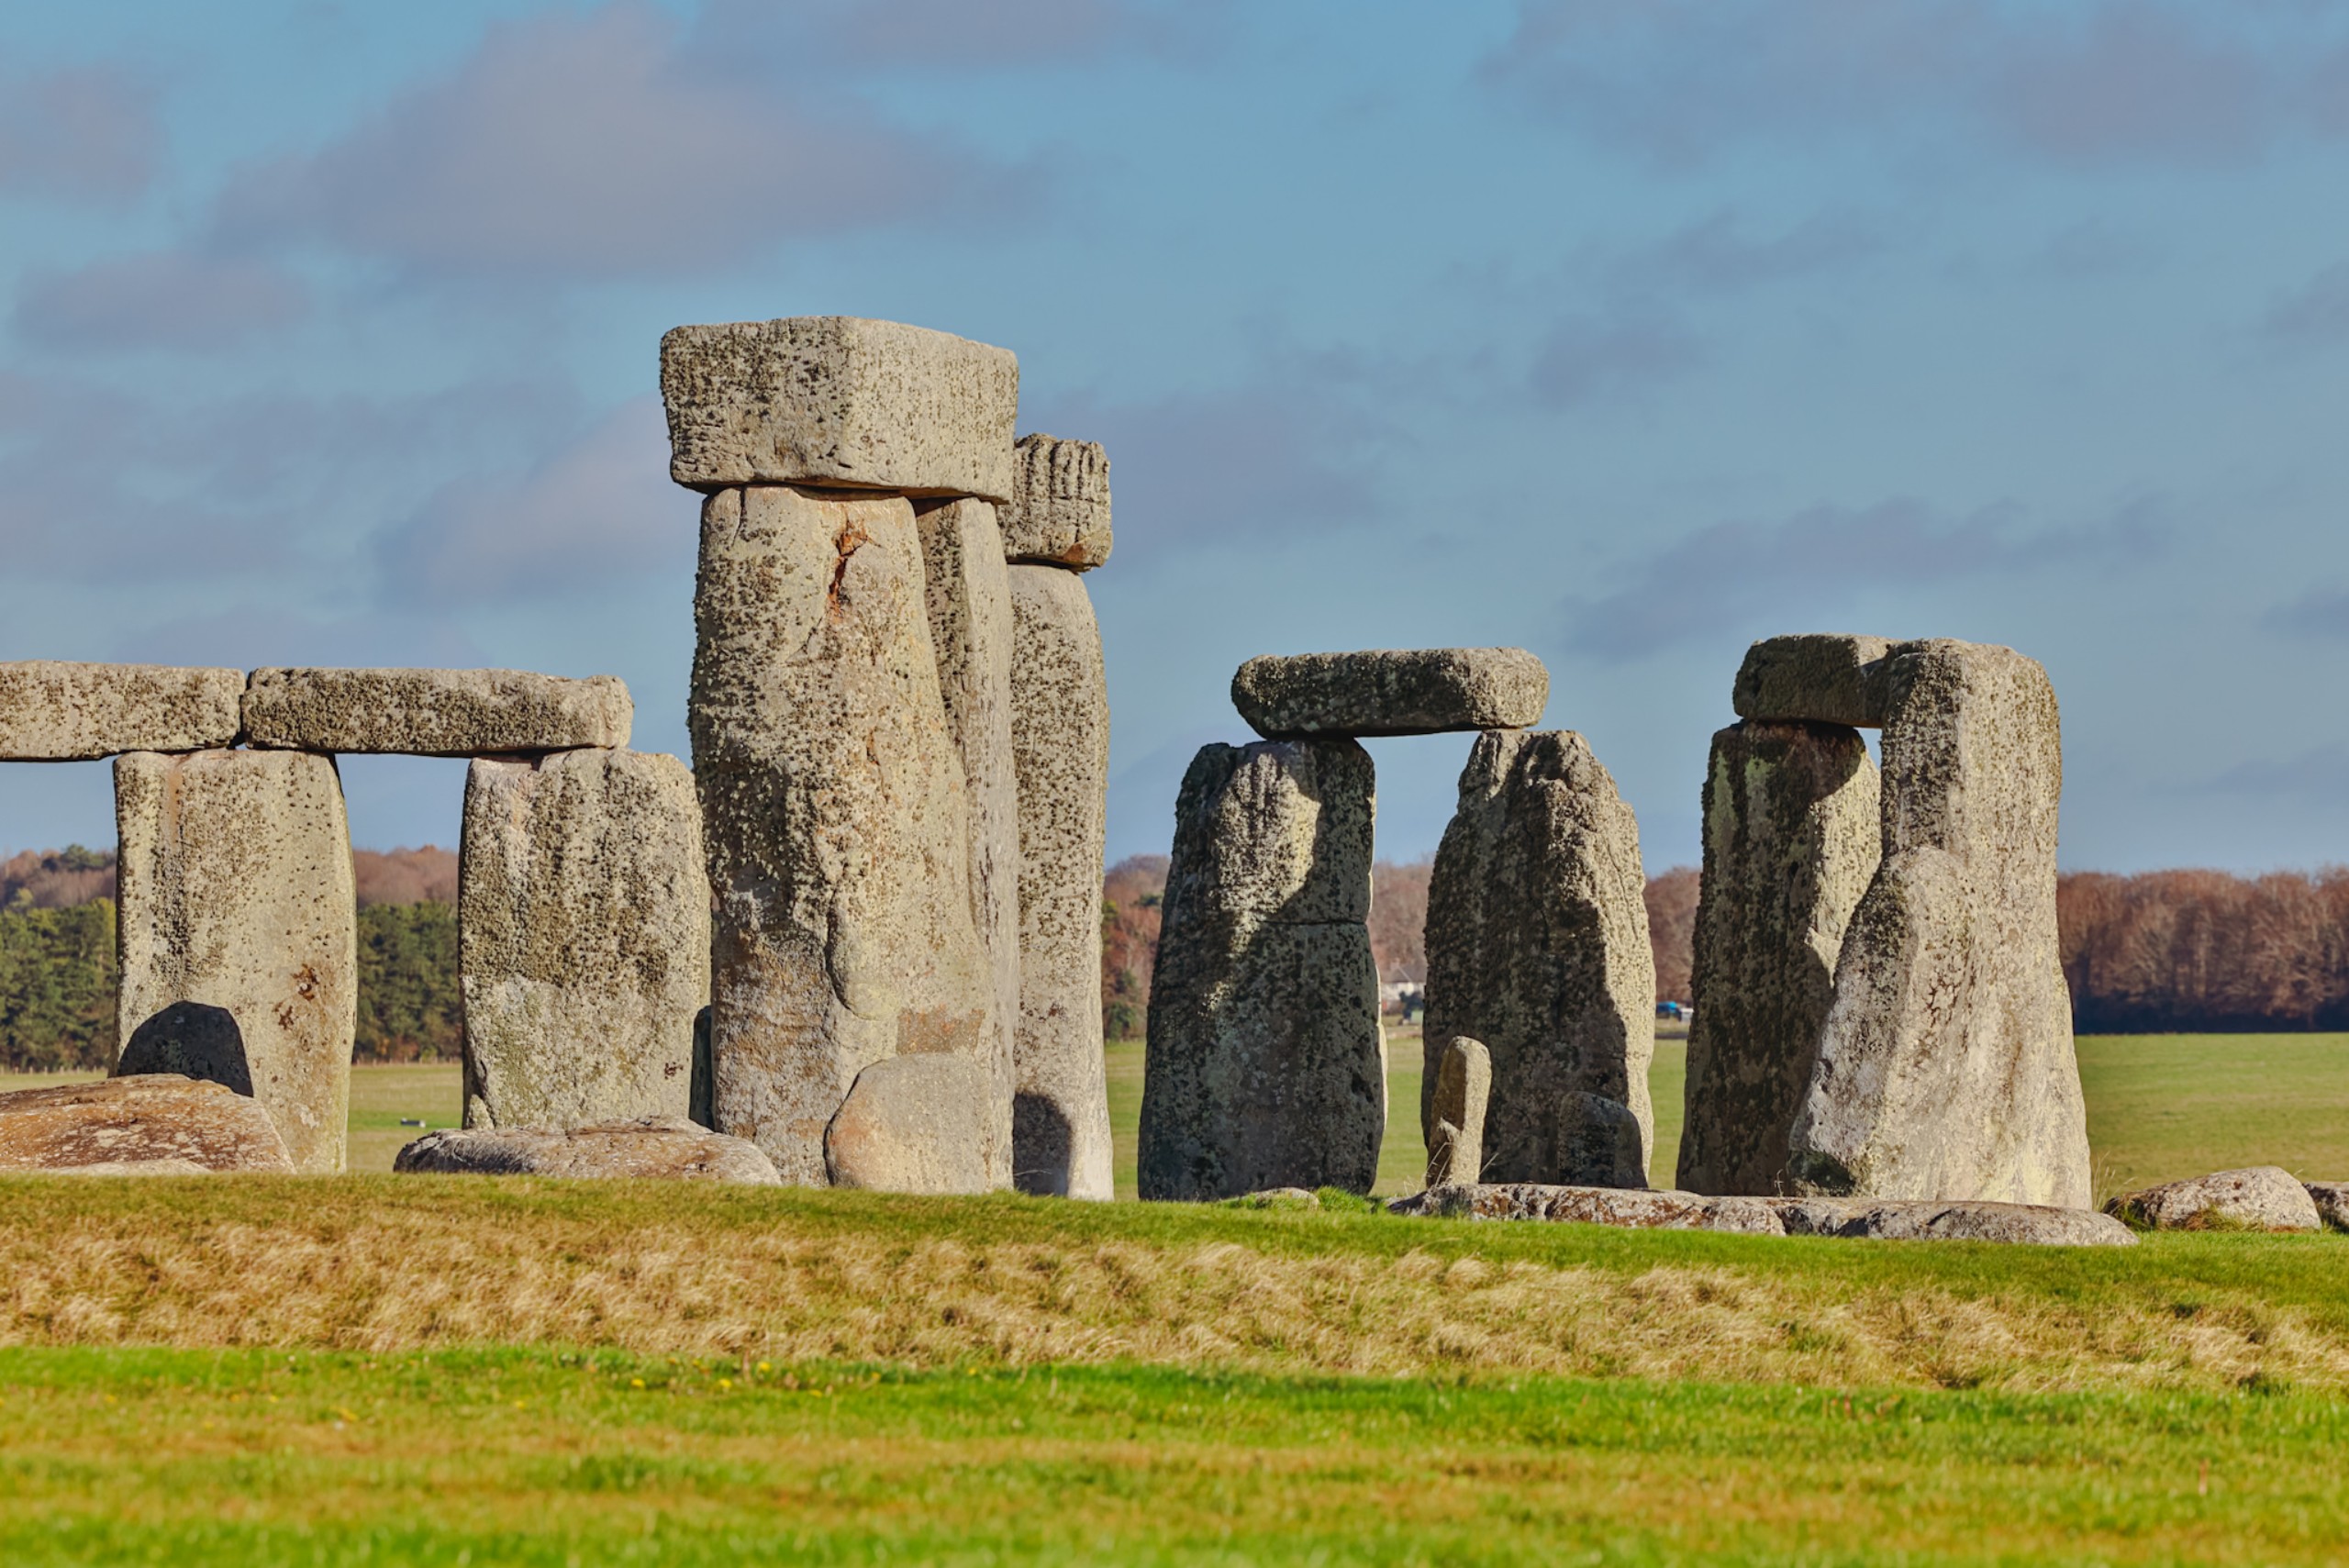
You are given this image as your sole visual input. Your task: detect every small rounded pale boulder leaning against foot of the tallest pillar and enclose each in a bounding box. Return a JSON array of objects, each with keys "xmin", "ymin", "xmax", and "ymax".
[{"xmin": 825, "ymin": 1056, "xmax": 998, "ymax": 1193}]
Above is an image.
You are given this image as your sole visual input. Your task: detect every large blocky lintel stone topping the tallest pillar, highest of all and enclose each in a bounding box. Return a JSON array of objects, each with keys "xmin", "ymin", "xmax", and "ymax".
[{"xmin": 660, "ymin": 317, "xmax": 1019, "ymax": 502}]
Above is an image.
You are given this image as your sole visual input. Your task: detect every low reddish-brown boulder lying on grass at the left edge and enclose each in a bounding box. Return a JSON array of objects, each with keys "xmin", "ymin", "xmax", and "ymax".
[{"xmin": 0, "ymin": 1073, "xmax": 294, "ymax": 1176}]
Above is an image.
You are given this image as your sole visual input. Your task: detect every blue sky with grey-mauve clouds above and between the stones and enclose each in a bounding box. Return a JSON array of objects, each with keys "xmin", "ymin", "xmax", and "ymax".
[{"xmin": 0, "ymin": 0, "xmax": 2349, "ymax": 871}]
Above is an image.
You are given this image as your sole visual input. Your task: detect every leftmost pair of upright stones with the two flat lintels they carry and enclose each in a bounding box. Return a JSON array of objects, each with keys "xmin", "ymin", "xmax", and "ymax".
[{"xmin": 0, "ymin": 662, "xmax": 709, "ymax": 1172}]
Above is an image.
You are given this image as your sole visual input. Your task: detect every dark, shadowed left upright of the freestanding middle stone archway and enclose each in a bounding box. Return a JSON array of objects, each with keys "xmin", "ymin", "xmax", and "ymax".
[{"xmin": 1140, "ymin": 740, "xmax": 1381, "ymax": 1199}]
